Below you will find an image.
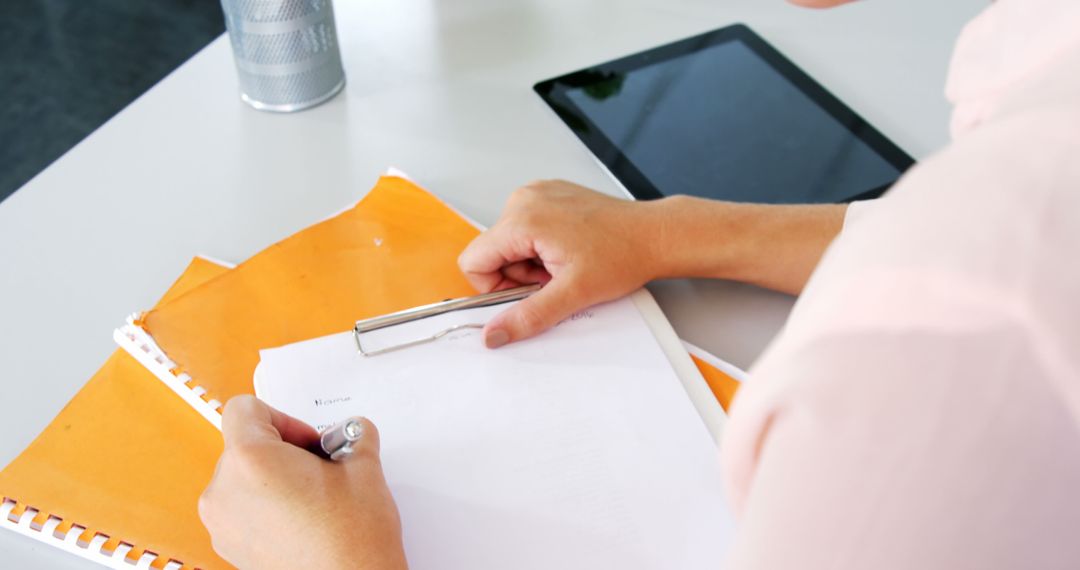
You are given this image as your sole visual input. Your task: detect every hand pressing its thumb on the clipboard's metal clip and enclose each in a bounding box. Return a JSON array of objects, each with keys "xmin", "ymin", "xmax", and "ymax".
[{"xmin": 458, "ymin": 180, "xmax": 663, "ymax": 348}]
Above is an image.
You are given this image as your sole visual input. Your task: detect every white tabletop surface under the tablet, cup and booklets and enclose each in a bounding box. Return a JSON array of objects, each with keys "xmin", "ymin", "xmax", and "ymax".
[{"xmin": 0, "ymin": 0, "xmax": 988, "ymax": 568}]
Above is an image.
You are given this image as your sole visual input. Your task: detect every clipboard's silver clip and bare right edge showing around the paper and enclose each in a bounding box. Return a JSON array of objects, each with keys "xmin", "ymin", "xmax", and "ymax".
[{"xmin": 353, "ymin": 285, "xmax": 727, "ymax": 446}]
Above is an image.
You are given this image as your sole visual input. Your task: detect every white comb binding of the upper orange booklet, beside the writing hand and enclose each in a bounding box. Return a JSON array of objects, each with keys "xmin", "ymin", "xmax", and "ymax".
[{"xmin": 112, "ymin": 314, "xmax": 221, "ymax": 430}]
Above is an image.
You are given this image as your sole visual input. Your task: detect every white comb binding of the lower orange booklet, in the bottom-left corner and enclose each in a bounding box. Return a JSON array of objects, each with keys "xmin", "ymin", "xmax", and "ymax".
[{"xmin": 0, "ymin": 497, "xmax": 184, "ymax": 570}]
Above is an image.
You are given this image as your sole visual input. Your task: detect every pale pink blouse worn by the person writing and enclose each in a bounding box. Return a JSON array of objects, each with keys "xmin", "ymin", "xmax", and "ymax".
[{"xmin": 724, "ymin": 0, "xmax": 1080, "ymax": 570}]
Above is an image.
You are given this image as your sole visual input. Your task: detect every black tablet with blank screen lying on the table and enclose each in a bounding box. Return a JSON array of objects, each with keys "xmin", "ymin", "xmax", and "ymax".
[{"xmin": 535, "ymin": 25, "xmax": 914, "ymax": 204}]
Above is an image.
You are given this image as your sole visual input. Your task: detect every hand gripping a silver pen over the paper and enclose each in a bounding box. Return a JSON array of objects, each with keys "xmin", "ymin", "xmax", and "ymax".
[{"xmin": 199, "ymin": 396, "xmax": 406, "ymax": 570}]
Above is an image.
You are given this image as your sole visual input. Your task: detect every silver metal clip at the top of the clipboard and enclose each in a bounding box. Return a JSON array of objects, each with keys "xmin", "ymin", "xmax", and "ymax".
[{"xmin": 352, "ymin": 285, "xmax": 540, "ymax": 356}]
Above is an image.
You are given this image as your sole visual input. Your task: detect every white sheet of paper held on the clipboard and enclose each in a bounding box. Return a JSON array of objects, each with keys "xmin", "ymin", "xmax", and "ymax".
[{"xmin": 255, "ymin": 299, "xmax": 732, "ymax": 570}]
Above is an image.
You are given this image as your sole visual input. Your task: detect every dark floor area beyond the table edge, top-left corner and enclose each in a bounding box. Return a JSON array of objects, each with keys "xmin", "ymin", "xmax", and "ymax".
[{"xmin": 0, "ymin": 0, "xmax": 225, "ymax": 201}]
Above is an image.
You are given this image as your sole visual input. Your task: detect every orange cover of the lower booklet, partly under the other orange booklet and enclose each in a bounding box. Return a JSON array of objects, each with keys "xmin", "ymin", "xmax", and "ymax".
[{"xmin": 0, "ymin": 258, "xmax": 228, "ymax": 568}]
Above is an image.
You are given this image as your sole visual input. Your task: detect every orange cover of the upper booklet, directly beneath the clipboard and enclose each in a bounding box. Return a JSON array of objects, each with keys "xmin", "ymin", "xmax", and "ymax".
[{"xmin": 138, "ymin": 176, "xmax": 480, "ymax": 412}]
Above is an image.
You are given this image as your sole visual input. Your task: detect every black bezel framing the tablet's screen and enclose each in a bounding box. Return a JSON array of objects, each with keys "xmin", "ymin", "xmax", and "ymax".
[{"xmin": 532, "ymin": 24, "xmax": 915, "ymax": 202}]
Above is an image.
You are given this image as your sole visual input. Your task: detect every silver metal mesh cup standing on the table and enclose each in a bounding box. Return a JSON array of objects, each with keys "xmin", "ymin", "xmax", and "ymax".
[{"xmin": 221, "ymin": 0, "xmax": 345, "ymax": 112}]
